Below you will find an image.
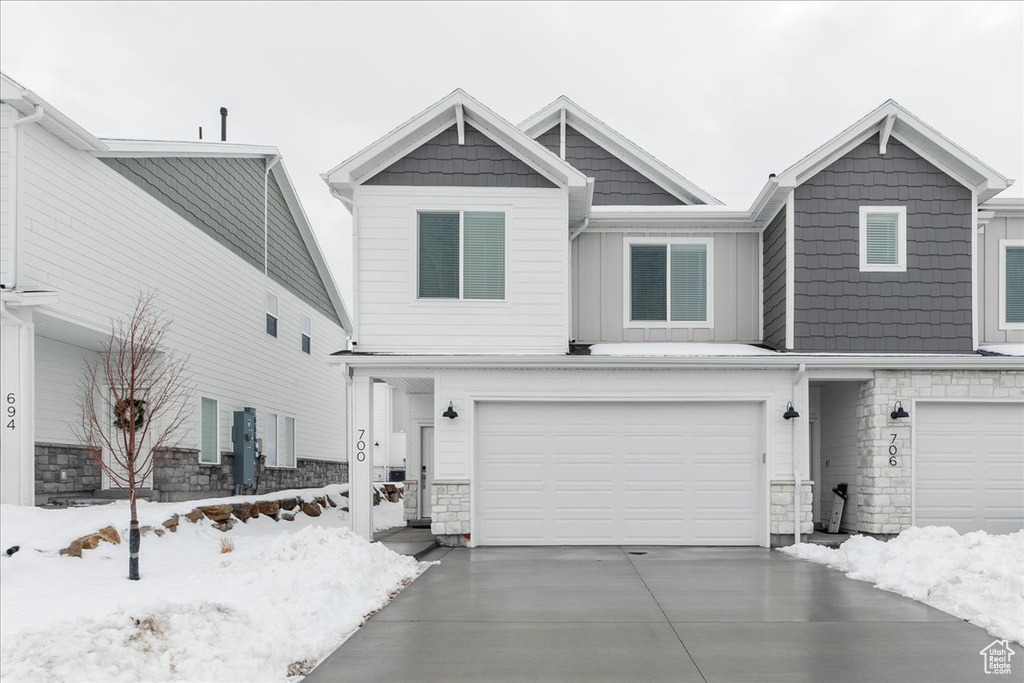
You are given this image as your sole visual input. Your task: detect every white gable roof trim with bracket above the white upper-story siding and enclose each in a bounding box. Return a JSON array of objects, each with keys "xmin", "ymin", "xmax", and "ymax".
[{"xmin": 321, "ymin": 89, "xmax": 592, "ymax": 222}]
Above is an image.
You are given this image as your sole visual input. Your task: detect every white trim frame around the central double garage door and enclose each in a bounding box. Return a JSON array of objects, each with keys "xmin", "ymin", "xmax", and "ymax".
[{"xmin": 466, "ymin": 392, "xmax": 772, "ymax": 548}]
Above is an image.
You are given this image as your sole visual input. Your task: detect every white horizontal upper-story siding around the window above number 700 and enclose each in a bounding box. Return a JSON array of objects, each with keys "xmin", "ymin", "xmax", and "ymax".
[{"xmin": 354, "ymin": 185, "xmax": 569, "ymax": 353}]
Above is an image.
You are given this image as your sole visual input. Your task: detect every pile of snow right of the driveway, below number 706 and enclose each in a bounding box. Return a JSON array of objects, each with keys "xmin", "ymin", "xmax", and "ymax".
[{"xmin": 780, "ymin": 526, "xmax": 1024, "ymax": 644}]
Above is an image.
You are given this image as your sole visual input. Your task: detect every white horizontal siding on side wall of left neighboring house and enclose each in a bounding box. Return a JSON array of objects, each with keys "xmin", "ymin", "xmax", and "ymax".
[{"xmin": 19, "ymin": 125, "xmax": 346, "ymax": 461}]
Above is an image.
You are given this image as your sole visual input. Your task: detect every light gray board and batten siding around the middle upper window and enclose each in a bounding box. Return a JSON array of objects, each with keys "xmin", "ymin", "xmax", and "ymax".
[{"xmin": 571, "ymin": 230, "xmax": 761, "ymax": 344}]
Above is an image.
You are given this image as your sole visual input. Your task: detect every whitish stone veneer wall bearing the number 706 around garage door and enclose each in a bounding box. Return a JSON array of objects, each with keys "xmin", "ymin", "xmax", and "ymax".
[{"xmin": 857, "ymin": 370, "xmax": 1024, "ymax": 536}]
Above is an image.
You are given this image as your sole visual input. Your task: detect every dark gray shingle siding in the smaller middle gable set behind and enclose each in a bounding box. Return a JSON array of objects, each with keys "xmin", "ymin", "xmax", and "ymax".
[{"xmin": 537, "ymin": 125, "xmax": 685, "ymax": 206}]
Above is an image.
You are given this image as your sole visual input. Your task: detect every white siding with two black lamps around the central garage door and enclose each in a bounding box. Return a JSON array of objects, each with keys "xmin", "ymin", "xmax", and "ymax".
[{"xmin": 433, "ymin": 370, "xmax": 807, "ymax": 481}]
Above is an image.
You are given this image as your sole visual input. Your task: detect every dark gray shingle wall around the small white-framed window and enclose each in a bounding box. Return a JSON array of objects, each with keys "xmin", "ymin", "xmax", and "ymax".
[{"xmin": 794, "ymin": 136, "xmax": 973, "ymax": 352}]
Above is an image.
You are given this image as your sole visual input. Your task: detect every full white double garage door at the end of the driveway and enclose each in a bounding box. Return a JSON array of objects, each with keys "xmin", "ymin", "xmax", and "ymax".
[{"xmin": 475, "ymin": 402, "xmax": 763, "ymax": 545}]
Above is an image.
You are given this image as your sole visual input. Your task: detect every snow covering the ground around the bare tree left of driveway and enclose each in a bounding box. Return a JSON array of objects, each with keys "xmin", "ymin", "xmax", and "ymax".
[{"xmin": 0, "ymin": 484, "xmax": 428, "ymax": 682}]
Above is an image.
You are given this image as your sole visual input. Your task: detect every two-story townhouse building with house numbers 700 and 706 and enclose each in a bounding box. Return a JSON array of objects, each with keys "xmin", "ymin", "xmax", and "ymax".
[{"xmin": 324, "ymin": 90, "xmax": 1024, "ymax": 546}]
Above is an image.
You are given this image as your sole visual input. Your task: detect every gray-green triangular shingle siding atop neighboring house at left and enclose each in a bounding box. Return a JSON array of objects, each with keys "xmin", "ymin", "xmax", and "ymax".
[{"xmin": 102, "ymin": 157, "xmax": 341, "ymax": 325}]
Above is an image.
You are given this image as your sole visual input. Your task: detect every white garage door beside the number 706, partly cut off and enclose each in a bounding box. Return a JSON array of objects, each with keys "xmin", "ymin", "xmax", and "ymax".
[{"xmin": 913, "ymin": 402, "xmax": 1024, "ymax": 533}]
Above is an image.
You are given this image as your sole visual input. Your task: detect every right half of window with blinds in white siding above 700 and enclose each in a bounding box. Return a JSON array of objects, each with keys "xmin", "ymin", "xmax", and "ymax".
[{"xmin": 462, "ymin": 211, "xmax": 505, "ymax": 299}]
